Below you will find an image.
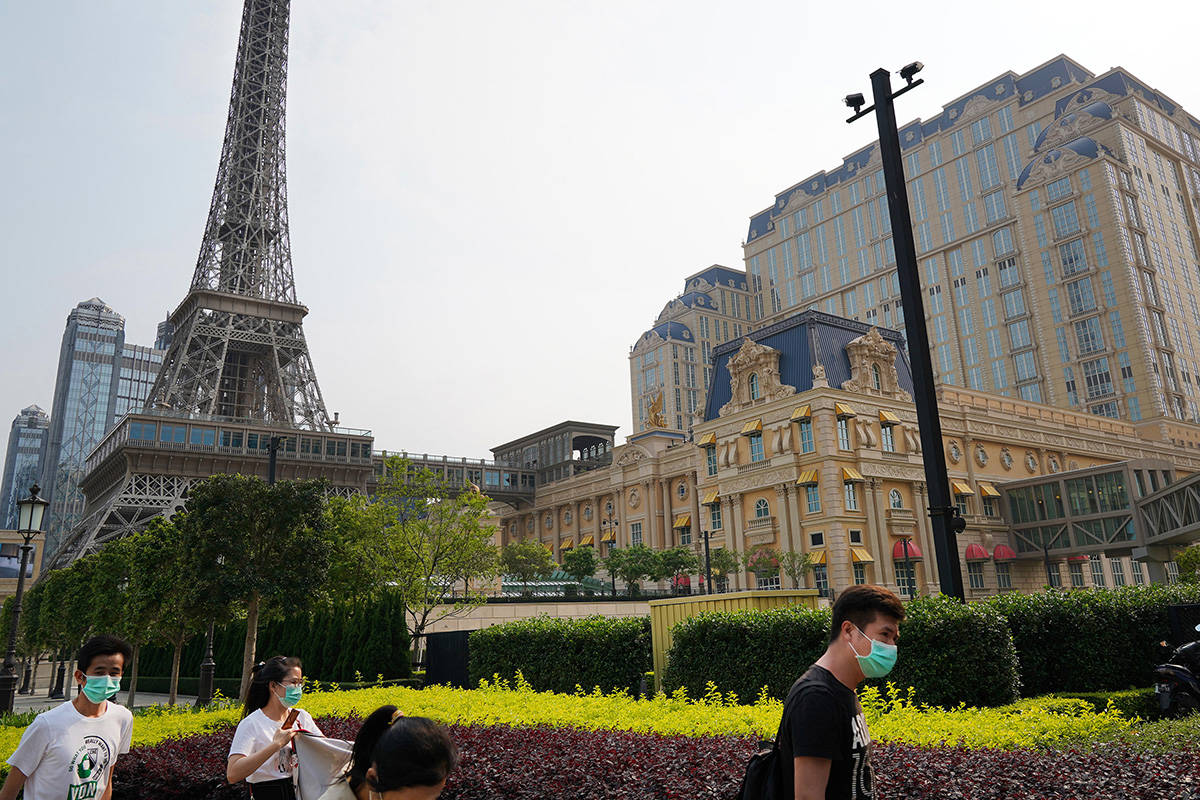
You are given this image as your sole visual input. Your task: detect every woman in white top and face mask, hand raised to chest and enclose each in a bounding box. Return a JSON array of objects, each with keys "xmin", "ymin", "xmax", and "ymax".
[{"xmin": 226, "ymin": 656, "xmax": 324, "ymax": 800}]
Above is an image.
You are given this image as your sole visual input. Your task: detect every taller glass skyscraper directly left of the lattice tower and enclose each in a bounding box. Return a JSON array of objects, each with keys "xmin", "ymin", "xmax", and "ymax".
[{"xmin": 42, "ymin": 297, "xmax": 162, "ymax": 554}]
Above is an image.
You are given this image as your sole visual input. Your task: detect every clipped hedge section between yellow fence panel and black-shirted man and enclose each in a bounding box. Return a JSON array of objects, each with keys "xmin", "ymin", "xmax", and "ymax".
[{"xmin": 662, "ymin": 607, "xmax": 829, "ymax": 703}]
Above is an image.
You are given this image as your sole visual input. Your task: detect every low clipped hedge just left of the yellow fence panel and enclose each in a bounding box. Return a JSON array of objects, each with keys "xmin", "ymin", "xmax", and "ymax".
[{"xmin": 469, "ymin": 616, "xmax": 652, "ymax": 693}]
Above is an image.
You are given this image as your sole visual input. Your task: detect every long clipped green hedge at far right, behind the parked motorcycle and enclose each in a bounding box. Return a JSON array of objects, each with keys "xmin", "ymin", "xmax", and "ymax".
[{"xmin": 979, "ymin": 584, "xmax": 1200, "ymax": 697}]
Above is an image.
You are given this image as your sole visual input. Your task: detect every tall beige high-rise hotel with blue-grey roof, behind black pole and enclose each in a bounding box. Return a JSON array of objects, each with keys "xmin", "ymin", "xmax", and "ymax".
[{"xmin": 745, "ymin": 56, "xmax": 1200, "ymax": 450}]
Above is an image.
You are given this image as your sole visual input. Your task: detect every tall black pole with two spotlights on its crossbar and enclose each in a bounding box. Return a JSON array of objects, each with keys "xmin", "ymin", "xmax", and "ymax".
[{"xmin": 842, "ymin": 61, "xmax": 966, "ymax": 601}]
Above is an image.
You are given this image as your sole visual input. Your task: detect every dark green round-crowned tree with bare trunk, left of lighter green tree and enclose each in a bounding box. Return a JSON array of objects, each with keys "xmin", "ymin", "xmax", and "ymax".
[{"xmin": 179, "ymin": 475, "xmax": 331, "ymax": 697}]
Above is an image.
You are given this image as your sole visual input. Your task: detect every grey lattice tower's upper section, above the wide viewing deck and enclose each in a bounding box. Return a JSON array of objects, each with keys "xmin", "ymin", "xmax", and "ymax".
[{"xmin": 148, "ymin": 0, "xmax": 331, "ymax": 431}]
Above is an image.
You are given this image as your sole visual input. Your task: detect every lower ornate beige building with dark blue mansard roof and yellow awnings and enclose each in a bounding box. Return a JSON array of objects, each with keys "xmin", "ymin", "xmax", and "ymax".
[{"xmin": 500, "ymin": 312, "xmax": 1200, "ymax": 597}]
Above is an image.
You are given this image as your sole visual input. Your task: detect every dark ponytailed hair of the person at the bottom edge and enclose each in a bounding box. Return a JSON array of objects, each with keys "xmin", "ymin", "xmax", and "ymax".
[{"xmin": 346, "ymin": 705, "xmax": 458, "ymax": 792}]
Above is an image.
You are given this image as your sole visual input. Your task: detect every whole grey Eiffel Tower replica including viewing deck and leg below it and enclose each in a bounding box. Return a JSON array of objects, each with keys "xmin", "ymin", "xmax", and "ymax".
[{"xmin": 50, "ymin": 0, "xmax": 372, "ymax": 569}]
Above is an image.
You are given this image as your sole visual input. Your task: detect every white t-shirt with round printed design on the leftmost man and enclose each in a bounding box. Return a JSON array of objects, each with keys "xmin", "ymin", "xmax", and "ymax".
[{"xmin": 8, "ymin": 700, "xmax": 133, "ymax": 800}]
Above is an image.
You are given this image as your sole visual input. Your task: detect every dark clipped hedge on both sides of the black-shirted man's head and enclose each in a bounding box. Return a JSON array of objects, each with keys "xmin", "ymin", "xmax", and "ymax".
[{"xmin": 662, "ymin": 597, "xmax": 1020, "ymax": 705}]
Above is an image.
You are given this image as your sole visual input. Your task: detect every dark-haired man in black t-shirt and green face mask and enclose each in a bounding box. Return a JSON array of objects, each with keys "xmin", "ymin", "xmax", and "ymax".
[{"xmin": 774, "ymin": 585, "xmax": 904, "ymax": 800}]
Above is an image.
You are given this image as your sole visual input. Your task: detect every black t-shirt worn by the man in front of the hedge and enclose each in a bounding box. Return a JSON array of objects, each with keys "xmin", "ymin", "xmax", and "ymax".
[{"xmin": 775, "ymin": 664, "xmax": 875, "ymax": 800}]
